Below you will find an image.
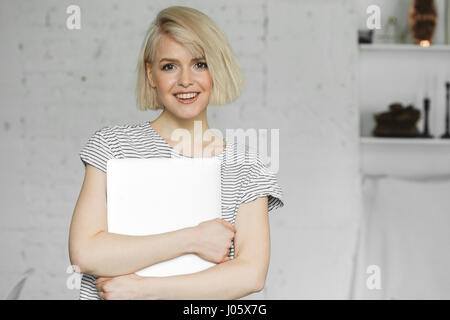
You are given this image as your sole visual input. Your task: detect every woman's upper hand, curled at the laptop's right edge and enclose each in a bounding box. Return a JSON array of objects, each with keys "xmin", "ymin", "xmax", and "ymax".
[{"xmin": 192, "ymin": 218, "xmax": 236, "ymax": 263}]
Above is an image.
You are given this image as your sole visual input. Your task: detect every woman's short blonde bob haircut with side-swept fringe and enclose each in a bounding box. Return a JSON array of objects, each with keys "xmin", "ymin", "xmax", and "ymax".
[{"xmin": 136, "ymin": 6, "xmax": 244, "ymax": 111}]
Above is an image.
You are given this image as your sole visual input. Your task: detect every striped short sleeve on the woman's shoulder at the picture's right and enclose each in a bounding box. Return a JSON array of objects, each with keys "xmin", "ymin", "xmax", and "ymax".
[{"xmin": 240, "ymin": 156, "xmax": 284, "ymax": 212}]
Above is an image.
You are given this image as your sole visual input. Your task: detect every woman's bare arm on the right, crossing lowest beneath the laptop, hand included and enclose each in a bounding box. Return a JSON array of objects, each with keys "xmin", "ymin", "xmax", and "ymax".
[{"xmin": 97, "ymin": 197, "xmax": 270, "ymax": 300}]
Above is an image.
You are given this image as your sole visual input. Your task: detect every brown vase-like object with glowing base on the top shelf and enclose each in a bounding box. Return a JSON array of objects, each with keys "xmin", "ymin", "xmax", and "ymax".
[{"xmin": 408, "ymin": 0, "xmax": 438, "ymax": 46}]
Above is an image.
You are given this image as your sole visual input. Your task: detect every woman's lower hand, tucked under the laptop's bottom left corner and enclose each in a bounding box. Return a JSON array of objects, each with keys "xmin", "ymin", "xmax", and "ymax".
[{"xmin": 95, "ymin": 273, "xmax": 146, "ymax": 300}]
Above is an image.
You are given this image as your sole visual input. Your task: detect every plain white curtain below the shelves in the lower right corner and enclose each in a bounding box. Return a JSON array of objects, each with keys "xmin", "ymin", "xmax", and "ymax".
[{"xmin": 352, "ymin": 176, "xmax": 450, "ymax": 299}]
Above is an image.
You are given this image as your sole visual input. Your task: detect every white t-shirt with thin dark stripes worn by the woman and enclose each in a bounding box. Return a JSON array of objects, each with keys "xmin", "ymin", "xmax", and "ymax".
[{"xmin": 75, "ymin": 121, "xmax": 284, "ymax": 300}]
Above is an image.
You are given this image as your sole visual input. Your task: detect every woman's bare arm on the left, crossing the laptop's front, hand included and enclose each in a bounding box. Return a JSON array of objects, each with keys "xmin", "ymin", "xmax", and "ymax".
[{"xmin": 69, "ymin": 165, "xmax": 234, "ymax": 277}]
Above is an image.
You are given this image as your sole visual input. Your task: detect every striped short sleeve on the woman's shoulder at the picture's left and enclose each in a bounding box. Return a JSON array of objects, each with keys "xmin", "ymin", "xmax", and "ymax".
[{"xmin": 80, "ymin": 129, "xmax": 114, "ymax": 173}]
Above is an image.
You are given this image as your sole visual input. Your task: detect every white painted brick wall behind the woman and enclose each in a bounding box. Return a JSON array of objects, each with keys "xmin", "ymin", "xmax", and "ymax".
[{"xmin": 0, "ymin": 0, "xmax": 360, "ymax": 299}]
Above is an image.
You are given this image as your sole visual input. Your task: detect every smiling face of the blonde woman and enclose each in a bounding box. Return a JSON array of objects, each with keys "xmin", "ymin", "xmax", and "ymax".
[{"xmin": 147, "ymin": 35, "xmax": 212, "ymax": 119}]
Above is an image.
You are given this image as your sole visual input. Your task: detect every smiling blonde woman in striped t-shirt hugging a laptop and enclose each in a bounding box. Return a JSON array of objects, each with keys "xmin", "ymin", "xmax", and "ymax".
[{"xmin": 69, "ymin": 6, "xmax": 283, "ymax": 299}]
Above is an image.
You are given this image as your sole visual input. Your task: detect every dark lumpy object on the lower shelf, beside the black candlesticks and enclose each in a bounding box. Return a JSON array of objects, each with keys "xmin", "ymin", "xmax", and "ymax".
[{"xmin": 372, "ymin": 103, "xmax": 421, "ymax": 137}]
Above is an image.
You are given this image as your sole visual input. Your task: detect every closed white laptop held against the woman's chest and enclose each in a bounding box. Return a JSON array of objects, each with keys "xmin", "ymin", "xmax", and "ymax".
[{"xmin": 107, "ymin": 158, "xmax": 221, "ymax": 277}]
